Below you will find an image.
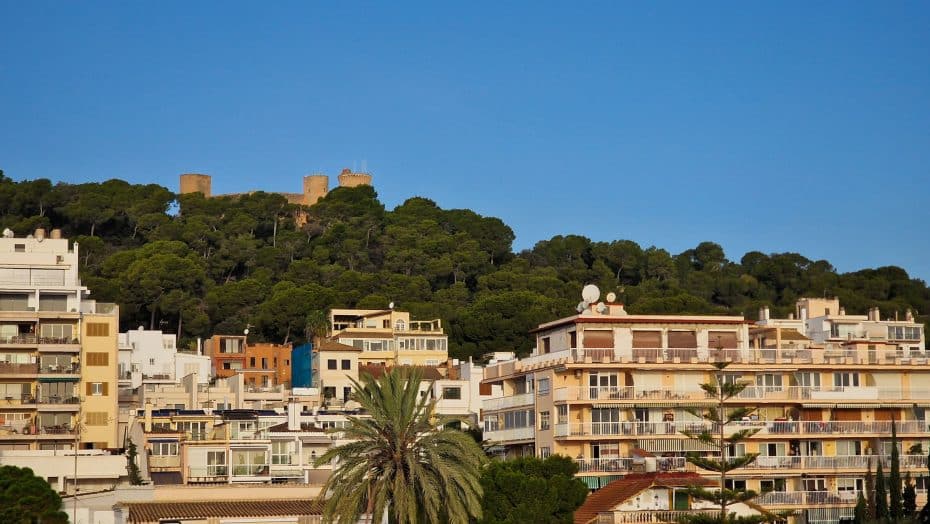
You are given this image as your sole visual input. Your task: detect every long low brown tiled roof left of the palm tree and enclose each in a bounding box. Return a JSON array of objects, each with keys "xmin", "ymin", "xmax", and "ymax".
[{"xmin": 125, "ymin": 499, "xmax": 323, "ymax": 523}]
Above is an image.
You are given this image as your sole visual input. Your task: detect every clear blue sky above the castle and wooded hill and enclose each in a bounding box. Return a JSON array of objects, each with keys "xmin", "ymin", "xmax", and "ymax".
[{"xmin": 0, "ymin": 0, "xmax": 930, "ymax": 279}]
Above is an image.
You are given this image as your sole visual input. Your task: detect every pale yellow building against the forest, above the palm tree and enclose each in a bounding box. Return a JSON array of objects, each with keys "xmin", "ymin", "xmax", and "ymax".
[{"xmin": 329, "ymin": 309, "xmax": 449, "ymax": 366}]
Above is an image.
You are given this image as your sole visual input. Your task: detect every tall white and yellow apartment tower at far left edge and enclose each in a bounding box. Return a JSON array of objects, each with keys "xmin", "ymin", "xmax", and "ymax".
[{"xmin": 0, "ymin": 229, "xmax": 119, "ymax": 452}]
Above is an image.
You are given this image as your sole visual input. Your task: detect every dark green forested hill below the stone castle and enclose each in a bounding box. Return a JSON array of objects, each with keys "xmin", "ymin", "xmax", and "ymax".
[{"xmin": 0, "ymin": 172, "xmax": 930, "ymax": 358}]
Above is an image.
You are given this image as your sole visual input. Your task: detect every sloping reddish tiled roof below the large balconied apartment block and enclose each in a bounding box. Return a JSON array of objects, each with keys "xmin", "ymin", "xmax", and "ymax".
[{"xmin": 575, "ymin": 473, "xmax": 717, "ymax": 524}]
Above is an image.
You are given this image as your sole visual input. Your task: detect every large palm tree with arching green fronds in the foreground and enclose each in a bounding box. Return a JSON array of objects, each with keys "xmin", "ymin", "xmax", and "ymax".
[{"xmin": 317, "ymin": 368, "xmax": 485, "ymax": 524}]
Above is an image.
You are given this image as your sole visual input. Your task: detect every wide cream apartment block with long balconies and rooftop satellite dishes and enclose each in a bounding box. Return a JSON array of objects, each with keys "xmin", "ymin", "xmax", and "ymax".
[{"xmin": 484, "ymin": 292, "xmax": 930, "ymax": 521}]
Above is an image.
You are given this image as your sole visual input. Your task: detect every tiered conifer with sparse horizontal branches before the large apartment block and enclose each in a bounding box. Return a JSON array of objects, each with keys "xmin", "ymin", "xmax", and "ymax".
[{"xmin": 682, "ymin": 362, "xmax": 779, "ymax": 524}]
